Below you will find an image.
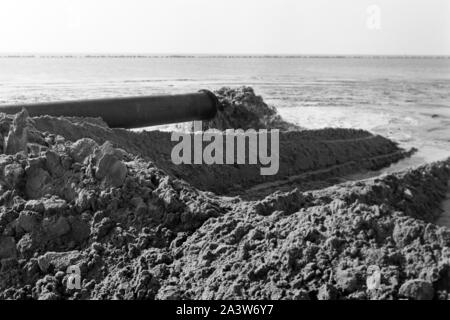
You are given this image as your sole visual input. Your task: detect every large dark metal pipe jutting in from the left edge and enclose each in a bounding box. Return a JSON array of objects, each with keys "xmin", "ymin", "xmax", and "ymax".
[{"xmin": 0, "ymin": 90, "xmax": 220, "ymax": 128}]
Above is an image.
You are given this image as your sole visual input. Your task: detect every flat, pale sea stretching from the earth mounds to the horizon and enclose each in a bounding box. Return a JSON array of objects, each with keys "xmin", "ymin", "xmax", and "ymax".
[{"xmin": 0, "ymin": 55, "xmax": 450, "ymax": 171}]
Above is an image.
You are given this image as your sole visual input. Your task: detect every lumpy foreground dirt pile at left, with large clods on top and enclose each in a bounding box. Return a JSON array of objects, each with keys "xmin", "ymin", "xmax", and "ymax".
[{"xmin": 0, "ymin": 111, "xmax": 228, "ymax": 299}]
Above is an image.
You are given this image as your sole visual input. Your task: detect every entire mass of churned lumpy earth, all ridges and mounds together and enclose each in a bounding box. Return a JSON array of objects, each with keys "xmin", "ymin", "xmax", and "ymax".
[{"xmin": 0, "ymin": 87, "xmax": 450, "ymax": 300}]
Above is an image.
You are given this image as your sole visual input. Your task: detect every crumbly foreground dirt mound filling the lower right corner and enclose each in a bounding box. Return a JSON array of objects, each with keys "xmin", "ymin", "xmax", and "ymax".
[{"xmin": 158, "ymin": 161, "xmax": 450, "ymax": 299}]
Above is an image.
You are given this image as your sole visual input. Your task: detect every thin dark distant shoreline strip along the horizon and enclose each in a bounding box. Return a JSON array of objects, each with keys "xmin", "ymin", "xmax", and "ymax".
[{"xmin": 0, "ymin": 54, "xmax": 450, "ymax": 59}]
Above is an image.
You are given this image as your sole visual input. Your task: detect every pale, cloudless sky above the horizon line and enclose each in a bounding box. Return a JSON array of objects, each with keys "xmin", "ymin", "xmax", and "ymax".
[{"xmin": 0, "ymin": 0, "xmax": 450, "ymax": 55}]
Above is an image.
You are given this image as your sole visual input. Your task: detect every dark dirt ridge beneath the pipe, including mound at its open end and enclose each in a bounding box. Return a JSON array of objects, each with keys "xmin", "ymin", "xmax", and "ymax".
[{"xmin": 29, "ymin": 87, "xmax": 412, "ymax": 196}]
